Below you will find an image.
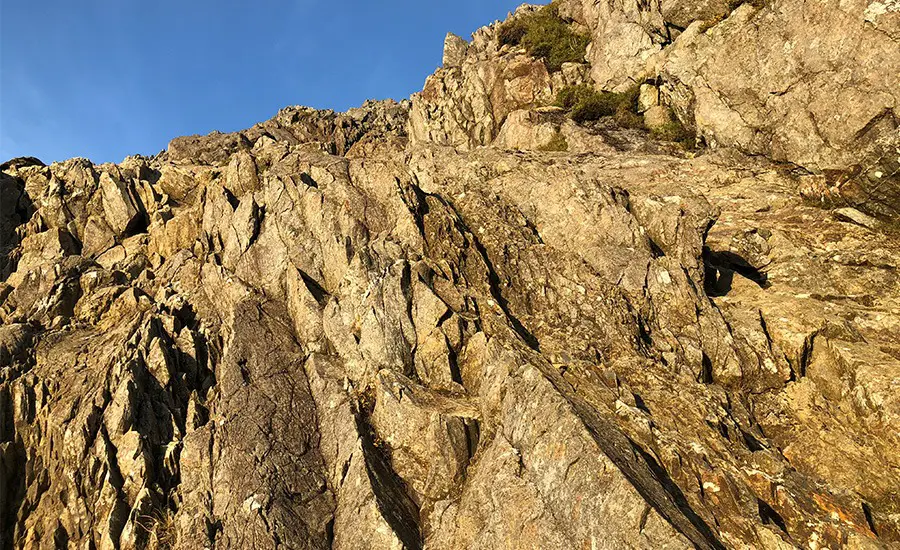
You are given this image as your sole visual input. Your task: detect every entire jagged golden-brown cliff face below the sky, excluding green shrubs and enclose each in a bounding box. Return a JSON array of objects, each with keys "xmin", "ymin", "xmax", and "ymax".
[{"xmin": 0, "ymin": 0, "xmax": 900, "ymax": 549}]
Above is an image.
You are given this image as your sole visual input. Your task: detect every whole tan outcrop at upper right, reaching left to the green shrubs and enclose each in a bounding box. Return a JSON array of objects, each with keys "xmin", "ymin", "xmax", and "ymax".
[{"xmin": 560, "ymin": 0, "xmax": 900, "ymax": 217}]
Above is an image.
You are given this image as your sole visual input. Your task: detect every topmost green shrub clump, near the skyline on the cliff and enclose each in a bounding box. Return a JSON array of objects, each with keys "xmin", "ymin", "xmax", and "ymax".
[{"xmin": 497, "ymin": 4, "xmax": 591, "ymax": 72}]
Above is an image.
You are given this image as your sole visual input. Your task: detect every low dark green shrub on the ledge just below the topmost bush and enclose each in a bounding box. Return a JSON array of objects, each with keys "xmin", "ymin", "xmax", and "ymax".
[{"xmin": 556, "ymin": 83, "xmax": 644, "ymax": 128}]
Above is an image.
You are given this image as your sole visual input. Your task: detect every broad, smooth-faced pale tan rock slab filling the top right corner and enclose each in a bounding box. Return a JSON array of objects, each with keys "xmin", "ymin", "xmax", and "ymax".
[{"xmin": 651, "ymin": 0, "xmax": 900, "ymax": 216}]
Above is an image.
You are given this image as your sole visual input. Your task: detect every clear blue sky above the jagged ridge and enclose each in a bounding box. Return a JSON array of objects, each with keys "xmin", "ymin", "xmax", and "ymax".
[{"xmin": 0, "ymin": 0, "xmax": 522, "ymax": 163}]
